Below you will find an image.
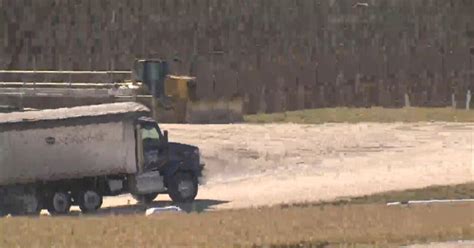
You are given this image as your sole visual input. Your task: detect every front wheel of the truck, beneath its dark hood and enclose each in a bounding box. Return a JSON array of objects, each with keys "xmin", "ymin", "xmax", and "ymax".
[{"xmin": 168, "ymin": 172, "xmax": 198, "ymax": 203}]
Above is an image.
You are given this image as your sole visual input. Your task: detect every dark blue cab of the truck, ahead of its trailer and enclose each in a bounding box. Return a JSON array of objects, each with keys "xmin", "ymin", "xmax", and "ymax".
[{"xmin": 133, "ymin": 117, "xmax": 204, "ymax": 203}]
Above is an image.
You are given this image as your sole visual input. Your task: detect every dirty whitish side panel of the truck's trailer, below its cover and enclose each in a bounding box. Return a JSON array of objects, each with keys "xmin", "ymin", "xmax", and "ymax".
[{"xmin": 0, "ymin": 120, "xmax": 137, "ymax": 185}]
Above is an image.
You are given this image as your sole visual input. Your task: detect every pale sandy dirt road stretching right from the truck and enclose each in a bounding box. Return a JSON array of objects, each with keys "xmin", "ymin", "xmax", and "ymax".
[{"xmin": 104, "ymin": 123, "xmax": 474, "ymax": 209}]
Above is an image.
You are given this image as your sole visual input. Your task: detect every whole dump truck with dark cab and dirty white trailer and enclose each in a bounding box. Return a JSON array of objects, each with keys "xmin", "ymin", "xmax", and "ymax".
[{"xmin": 0, "ymin": 102, "xmax": 204, "ymax": 216}]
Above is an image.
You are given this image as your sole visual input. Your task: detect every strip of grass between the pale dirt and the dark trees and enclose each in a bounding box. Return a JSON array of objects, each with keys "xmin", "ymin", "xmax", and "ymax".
[{"xmin": 244, "ymin": 107, "xmax": 474, "ymax": 124}]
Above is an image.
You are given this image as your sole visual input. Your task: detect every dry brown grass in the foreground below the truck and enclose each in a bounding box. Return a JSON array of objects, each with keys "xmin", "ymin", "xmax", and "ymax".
[{"xmin": 0, "ymin": 183, "xmax": 474, "ymax": 247}]
